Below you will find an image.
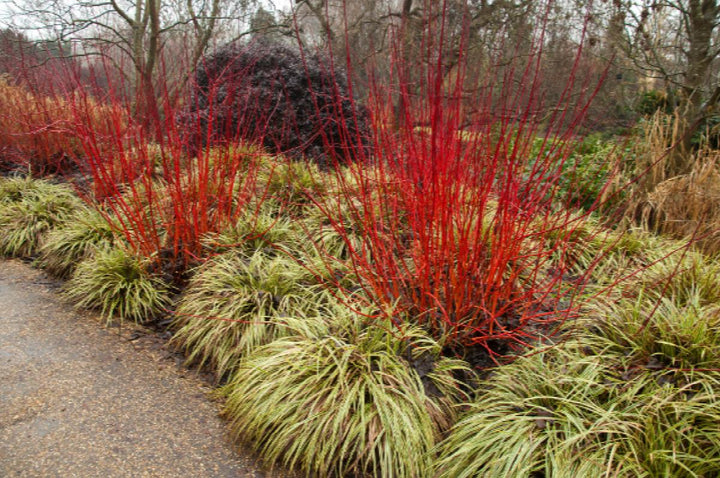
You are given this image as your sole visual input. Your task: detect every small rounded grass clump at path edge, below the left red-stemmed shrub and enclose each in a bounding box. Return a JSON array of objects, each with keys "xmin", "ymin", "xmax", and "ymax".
[{"xmin": 64, "ymin": 247, "xmax": 171, "ymax": 323}]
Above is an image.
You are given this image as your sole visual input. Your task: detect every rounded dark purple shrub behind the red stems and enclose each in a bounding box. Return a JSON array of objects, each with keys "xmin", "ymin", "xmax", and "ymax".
[{"xmin": 180, "ymin": 41, "xmax": 369, "ymax": 165}]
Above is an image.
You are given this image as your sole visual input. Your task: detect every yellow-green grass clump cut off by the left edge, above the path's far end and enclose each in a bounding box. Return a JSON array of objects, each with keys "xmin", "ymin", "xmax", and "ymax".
[{"xmin": 0, "ymin": 179, "xmax": 82, "ymax": 257}]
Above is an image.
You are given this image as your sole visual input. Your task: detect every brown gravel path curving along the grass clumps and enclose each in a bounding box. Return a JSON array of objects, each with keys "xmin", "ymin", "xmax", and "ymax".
[{"xmin": 0, "ymin": 261, "xmax": 277, "ymax": 478}]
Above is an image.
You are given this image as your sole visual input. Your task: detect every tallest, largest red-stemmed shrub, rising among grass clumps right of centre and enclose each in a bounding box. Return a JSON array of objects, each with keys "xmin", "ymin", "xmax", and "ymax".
[{"xmin": 318, "ymin": 2, "xmax": 612, "ymax": 365}]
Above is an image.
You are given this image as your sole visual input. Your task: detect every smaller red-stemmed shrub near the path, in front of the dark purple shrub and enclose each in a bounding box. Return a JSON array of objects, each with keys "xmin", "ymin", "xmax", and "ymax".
[{"xmin": 62, "ymin": 58, "xmax": 266, "ymax": 285}]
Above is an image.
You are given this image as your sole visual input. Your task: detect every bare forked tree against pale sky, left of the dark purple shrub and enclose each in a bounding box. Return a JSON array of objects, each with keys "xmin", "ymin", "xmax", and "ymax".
[{"xmin": 0, "ymin": 0, "xmax": 255, "ymax": 131}]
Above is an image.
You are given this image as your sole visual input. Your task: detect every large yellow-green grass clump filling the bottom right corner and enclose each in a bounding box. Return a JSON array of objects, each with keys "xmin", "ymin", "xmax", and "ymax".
[{"xmin": 435, "ymin": 344, "xmax": 720, "ymax": 478}]
